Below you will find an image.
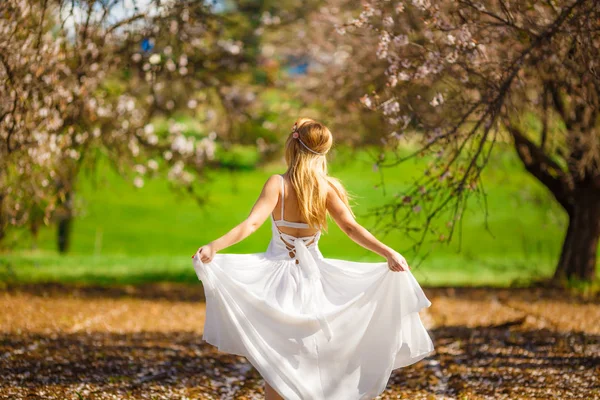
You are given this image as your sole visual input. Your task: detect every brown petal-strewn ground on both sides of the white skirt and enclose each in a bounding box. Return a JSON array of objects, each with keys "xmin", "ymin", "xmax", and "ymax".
[{"xmin": 0, "ymin": 284, "xmax": 600, "ymax": 400}]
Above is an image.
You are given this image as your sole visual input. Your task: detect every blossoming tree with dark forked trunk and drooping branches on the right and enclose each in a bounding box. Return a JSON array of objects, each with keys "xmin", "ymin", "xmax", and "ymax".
[{"xmin": 338, "ymin": 0, "xmax": 600, "ymax": 280}]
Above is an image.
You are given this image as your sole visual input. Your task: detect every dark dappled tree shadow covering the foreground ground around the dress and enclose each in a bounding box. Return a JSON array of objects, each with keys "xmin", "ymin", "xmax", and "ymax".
[{"xmin": 0, "ymin": 326, "xmax": 600, "ymax": 399}]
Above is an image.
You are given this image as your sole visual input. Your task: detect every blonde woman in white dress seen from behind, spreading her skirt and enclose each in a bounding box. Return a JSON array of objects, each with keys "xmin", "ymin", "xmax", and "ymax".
[{"xmin": 192, "ymin": 118, "xmax": 433, "ymax": 400}]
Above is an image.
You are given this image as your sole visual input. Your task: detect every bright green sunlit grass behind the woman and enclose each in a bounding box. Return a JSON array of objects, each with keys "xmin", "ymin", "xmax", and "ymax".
[{"xmin": 0, "ymin": 145, "xmax": 596, "ymax": 285}]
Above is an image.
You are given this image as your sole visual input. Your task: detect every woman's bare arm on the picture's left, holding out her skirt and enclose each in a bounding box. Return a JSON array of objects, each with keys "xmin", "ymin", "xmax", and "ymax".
[{"xmin": 192, "ymin": 175, "xmax": 281, "ymax": 263}]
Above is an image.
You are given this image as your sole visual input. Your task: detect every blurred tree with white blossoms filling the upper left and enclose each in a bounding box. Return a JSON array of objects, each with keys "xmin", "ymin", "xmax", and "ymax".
[{"xmin": 0, "ymin": 0, "xmax": 262, "ymax": 251}]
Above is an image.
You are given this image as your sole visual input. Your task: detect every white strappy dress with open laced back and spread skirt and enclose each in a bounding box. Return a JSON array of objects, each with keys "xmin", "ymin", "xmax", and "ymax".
[{"xmin": 193, "ymin": 177, "xmax": 433, "ymax": 400}]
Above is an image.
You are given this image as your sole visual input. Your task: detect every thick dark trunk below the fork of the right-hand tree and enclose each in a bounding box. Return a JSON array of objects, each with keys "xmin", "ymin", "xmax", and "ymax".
[{"xmin": 554, "ymin": 189, "xmax": 600, "ymax": 281}]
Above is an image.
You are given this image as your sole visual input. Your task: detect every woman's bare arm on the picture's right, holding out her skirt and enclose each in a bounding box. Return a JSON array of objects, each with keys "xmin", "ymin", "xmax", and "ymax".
[{"xmin": 327, "ymin": 186, "xmax": 410, "ymax": 271}]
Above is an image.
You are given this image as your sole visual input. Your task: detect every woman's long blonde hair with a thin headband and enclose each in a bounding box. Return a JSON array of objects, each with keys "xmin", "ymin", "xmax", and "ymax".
[{"xmin": 285, "ymin": 118, "xmax": 352, "ymax": 229}]
